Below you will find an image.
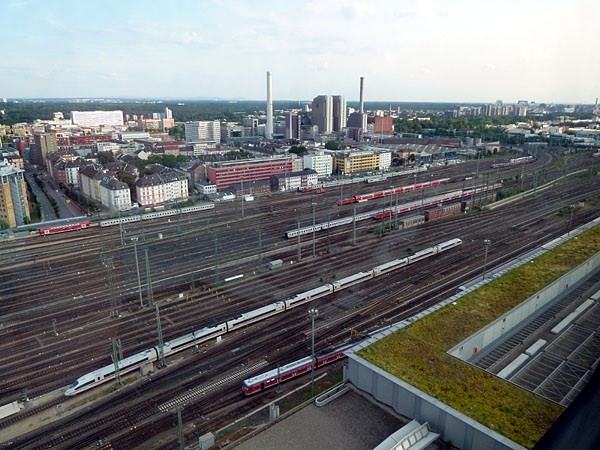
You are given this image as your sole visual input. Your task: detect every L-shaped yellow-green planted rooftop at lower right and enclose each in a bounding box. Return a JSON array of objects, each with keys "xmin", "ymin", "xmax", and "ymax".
[{"xmin": 358, "ymin": 226, "xmax": 600, "ymax": 448}]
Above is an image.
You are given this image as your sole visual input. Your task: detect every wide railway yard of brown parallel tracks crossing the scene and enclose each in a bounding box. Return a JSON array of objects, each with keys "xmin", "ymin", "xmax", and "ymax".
[{"xmin": 0, "ymin": 151, "xmax": 600, "ymax": 449}]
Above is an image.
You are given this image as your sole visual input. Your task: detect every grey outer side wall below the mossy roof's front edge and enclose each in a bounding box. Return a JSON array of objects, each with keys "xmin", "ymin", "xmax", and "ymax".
[{"xmin": 348, "ymin": 354, "xmax": 525, "ymax": 450}]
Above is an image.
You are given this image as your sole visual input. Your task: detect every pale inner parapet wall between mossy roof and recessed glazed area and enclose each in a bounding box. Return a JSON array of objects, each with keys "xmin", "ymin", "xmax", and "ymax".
[{"xmin": 448, "ymin": 253, "xmax": 600, "ymax": 361}]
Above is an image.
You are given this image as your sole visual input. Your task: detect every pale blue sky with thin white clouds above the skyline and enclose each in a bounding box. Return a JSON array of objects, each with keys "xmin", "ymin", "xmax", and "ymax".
[{"xmin": 0, "ymin": 0, "xmax": 600, "ymax": 103}]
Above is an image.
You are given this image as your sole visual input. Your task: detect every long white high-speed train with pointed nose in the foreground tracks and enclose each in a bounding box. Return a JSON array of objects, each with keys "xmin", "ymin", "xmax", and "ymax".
[{"xmin": 65, "ymin": 239, "xmax": 462, "ymax": 396}]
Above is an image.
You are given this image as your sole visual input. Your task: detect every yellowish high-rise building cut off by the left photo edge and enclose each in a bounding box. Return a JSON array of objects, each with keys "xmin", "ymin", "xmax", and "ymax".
[{"xmin": 0, "ymin": 160, "xmax": 30, "ymax": 228}]
